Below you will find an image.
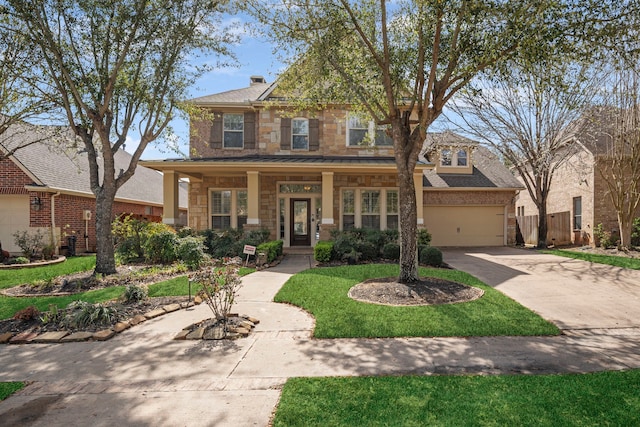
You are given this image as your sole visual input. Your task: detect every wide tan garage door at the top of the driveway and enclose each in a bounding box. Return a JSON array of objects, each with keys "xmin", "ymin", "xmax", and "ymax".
[{"xmin": 424, "ymin": 206, "xmax": 505, "ymax": 246}]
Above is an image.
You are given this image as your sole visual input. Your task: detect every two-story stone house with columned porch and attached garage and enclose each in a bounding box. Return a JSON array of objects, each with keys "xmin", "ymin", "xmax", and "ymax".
[{"xmin": 143, "ymin": 76, "xmax": 521, "ymax": 247}]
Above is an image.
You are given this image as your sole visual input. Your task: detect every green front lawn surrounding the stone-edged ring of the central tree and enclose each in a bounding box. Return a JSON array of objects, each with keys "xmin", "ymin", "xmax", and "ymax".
[{"xmin": 275, "ymin": 264, "xmax": 559, "ymax": 338}]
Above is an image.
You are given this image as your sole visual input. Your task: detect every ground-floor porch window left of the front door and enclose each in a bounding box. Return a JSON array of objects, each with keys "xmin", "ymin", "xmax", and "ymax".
[{"xmin": 210, "ymin": 189, "xmax": 248, "ymax": 230}]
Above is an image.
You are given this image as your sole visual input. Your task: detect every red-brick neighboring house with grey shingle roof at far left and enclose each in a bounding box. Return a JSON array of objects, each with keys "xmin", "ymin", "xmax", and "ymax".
[{"xmin": 0, "ymin": 124, "xmax": 187, "ymax": 254}]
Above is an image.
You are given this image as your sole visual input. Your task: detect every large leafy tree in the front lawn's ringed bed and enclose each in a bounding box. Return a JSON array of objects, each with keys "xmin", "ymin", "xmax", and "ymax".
[{"xmin": 247, "ymin": 0, "xmax": 613, "ymax": 283}]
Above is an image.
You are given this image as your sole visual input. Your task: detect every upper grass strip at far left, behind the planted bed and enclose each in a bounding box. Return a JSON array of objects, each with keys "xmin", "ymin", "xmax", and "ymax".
[{"xmin": 0, "ymin": 256, "xmax": 96, "ymax": 289}]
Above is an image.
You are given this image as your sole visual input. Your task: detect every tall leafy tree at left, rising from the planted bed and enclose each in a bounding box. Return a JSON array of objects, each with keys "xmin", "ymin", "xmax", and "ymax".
[{"xmin": 4, "ymin": 0, "xmax": 234, "ymax": 274}]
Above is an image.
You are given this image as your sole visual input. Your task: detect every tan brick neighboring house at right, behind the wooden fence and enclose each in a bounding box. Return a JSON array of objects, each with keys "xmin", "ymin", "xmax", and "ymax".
[{"xmin": 516, "ymin": 123, "xmax": 640, "ymax": 246}]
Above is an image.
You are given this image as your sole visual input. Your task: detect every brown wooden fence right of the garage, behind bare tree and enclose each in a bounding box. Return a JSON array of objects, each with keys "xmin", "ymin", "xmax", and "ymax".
[{"xmin": 516, "ymin": 211, "xmax": 571, "ymax": 246}]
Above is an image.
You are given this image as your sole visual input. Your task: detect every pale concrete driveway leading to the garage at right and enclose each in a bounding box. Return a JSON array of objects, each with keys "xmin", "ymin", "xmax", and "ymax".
[{"xmin": 443, "ymin": 247, "xmax": 640, "ymax": 330}]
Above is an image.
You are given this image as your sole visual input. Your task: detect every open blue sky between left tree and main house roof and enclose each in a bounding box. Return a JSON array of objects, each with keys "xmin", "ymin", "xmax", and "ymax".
[{"xmin": 139, "ymin": 21, "xmax": 282, "ymax": 160}]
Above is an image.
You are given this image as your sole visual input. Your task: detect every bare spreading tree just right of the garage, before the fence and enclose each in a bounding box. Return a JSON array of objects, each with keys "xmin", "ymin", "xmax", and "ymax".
[{"xmin": 449, "ymin": 58, "xmax": 603, "ymax": 247}]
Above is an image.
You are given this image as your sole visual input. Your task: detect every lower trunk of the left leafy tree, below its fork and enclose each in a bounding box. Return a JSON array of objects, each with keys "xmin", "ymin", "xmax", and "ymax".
[{"xmin": 94, "ymin": 188, "xmax": 116, "ymax": 275}]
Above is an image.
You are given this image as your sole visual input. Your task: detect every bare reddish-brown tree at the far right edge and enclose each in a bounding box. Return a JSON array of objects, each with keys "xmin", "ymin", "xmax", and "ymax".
[{"xmin": 597, "ymin": 63, "xmax": 640, "ymax": 248}]
